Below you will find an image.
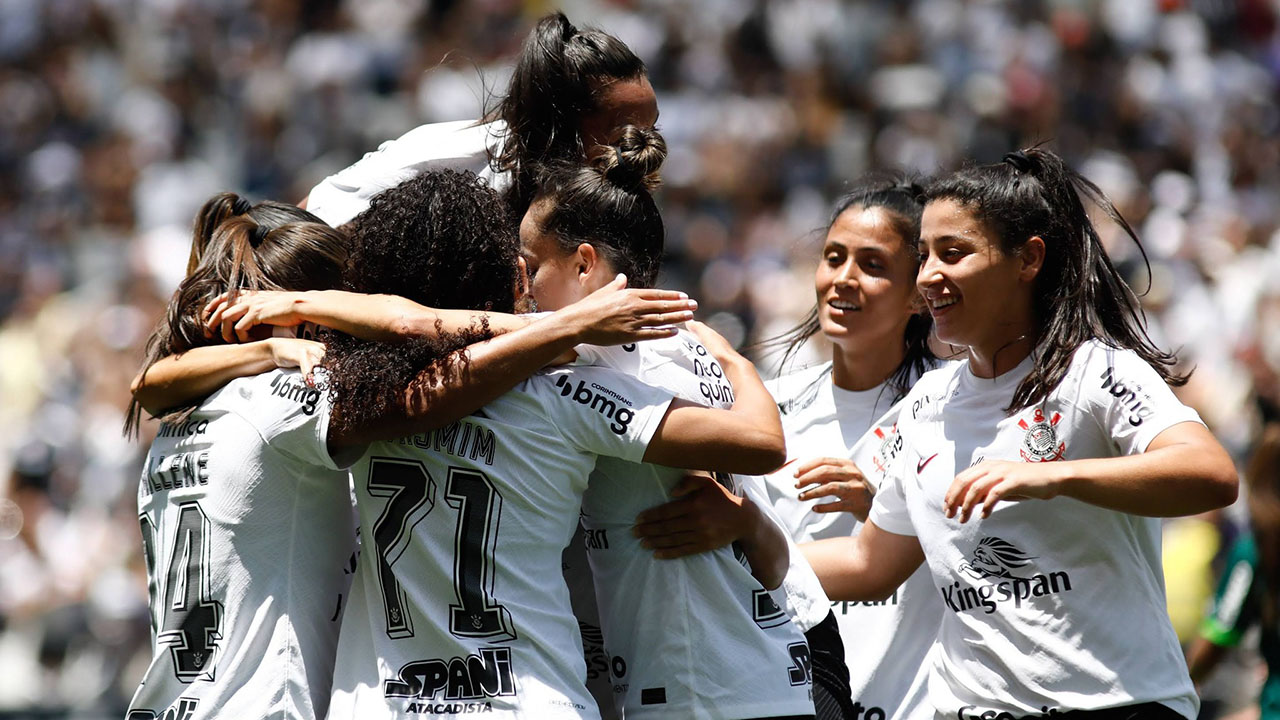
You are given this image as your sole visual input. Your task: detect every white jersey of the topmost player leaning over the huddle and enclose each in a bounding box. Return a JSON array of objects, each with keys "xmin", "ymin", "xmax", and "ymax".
[{"xmin": 307, "ymin": 120, "xmax": 511, "ymax": 227}]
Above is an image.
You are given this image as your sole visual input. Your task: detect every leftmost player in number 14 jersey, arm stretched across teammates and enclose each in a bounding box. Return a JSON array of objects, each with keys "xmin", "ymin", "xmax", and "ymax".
[{"xmin": 131, "ymin": 185, "xmax": 696, "ymax": 719}]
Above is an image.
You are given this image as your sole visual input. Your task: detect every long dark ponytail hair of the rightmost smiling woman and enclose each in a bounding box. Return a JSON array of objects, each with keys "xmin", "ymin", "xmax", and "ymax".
[{"xmin": 924, "ymin": 147, "xmax": 1187, "ymax": 413}]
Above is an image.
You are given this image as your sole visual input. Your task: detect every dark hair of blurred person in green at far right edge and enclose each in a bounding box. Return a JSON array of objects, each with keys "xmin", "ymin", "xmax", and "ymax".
[{"xmin": 1245, "ymin": 423, "xmax": 1280, "ymax": 637}]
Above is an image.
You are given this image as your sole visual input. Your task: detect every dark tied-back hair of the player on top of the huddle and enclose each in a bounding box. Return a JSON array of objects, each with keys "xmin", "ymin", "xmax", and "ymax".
[{"xmin": 485, "ymin": 13, "xmax": 645, "ymax": 213}]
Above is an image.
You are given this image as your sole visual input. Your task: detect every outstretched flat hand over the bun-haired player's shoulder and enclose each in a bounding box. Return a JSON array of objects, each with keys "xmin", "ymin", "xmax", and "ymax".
[{"xmin": 556, "ymin": 275, "xmax": 698, "ymax": 345}]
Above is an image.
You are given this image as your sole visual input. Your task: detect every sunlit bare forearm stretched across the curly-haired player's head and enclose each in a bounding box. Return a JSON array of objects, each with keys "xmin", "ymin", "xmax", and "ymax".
[{"xmin": 293, "ymin": 290, "xmax": 527, "ymax": 342}]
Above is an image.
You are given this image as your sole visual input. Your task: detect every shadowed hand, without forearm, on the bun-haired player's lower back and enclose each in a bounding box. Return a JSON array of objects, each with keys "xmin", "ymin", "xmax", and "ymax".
[{"xmin": 631, "ymin": 474, "xmax": 751, "ymax": 560}]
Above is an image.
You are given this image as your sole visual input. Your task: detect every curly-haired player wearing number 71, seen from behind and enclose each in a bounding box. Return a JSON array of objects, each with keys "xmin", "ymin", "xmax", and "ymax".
[{"xmin": 313, "ymin": 173, "xmax": 783, "ymax": 719}]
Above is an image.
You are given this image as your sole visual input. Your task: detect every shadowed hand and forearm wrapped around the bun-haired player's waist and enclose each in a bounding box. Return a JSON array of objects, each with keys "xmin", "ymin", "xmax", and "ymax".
[{"xmin": 632, "ymin": 474, "xmax": 791, "ymax": 589}]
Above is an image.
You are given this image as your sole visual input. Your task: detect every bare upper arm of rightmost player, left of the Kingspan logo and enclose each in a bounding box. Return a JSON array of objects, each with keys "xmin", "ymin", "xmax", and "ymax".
[{"xmin": 799, "ymin": 520, "xmax": 924, "ymax": 601}]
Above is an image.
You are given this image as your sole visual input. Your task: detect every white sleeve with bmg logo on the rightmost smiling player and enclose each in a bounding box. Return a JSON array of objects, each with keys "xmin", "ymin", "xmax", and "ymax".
[{"xmin": 1078, "ymin": 343, "xmax": 1202, "ymax": 455}]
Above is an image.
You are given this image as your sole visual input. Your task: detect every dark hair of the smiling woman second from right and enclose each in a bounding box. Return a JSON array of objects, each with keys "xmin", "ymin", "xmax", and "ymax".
[{"xmin": 763, "ymin": 173, "xmax": 937, "ymax": 402}]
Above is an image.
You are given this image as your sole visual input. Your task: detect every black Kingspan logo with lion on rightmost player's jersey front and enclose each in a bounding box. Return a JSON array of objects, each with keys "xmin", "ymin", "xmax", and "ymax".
[{"xmin": 938, "ymin": 537, "xmax": 1071, "ymax": 615}]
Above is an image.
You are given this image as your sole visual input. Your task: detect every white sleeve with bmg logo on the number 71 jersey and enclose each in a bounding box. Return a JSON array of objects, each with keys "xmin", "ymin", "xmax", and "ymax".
[{"xmin": 530, "ymin": 366, "xmax": 673, "ymax": 462}]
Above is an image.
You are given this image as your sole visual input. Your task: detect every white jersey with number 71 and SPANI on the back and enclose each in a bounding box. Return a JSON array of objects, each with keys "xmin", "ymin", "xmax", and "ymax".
[{"xmin": 329, "ymin": 368, "xmax": 671, "ymax": 720}]
